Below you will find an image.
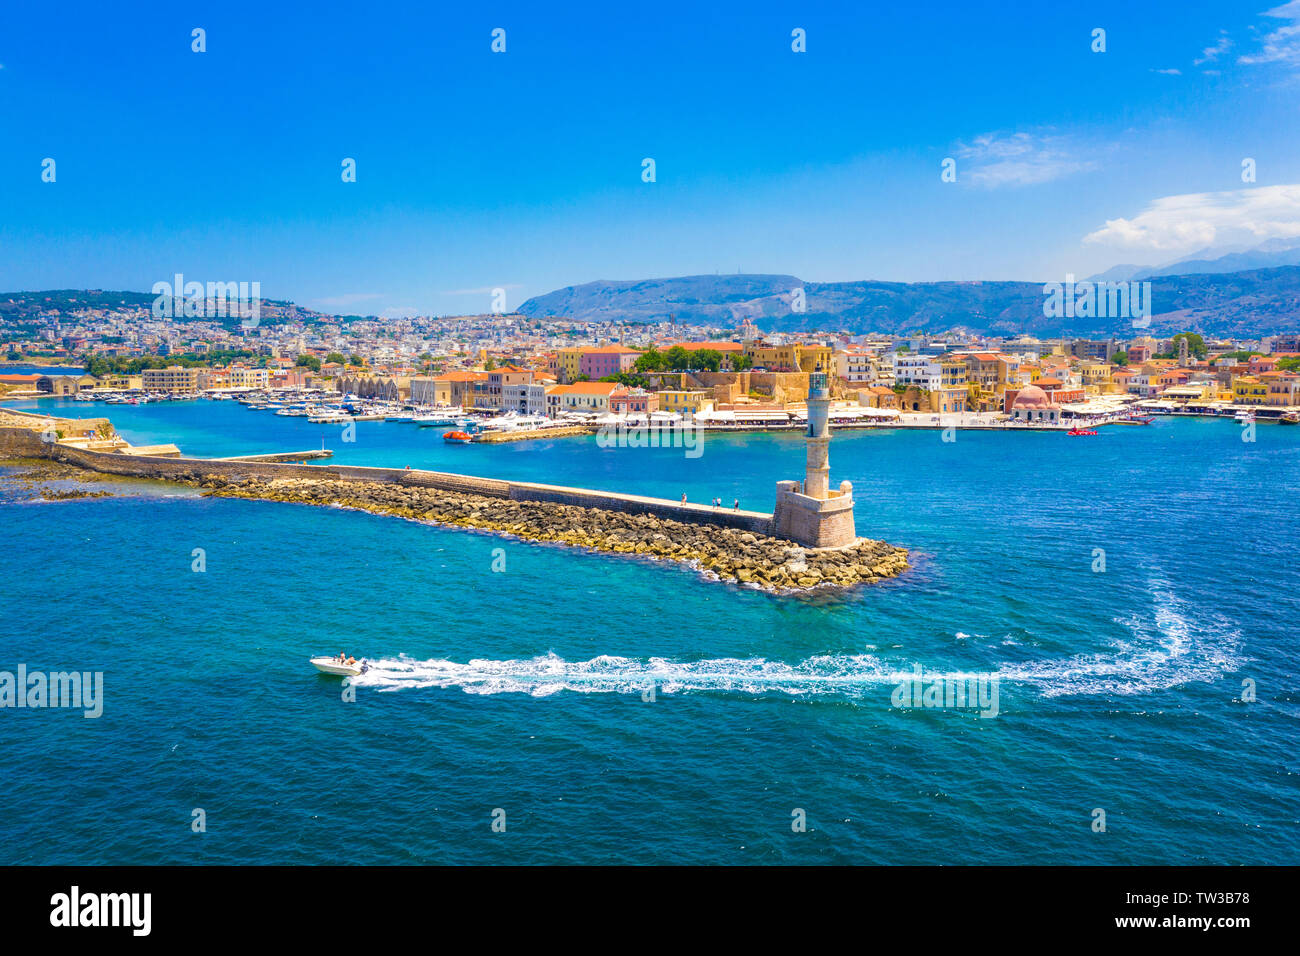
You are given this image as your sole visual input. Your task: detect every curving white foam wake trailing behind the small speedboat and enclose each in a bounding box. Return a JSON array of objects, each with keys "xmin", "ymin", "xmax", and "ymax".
[{"xmin": 354, "ymin": 582, "xmax": 1243, "ymax": 700}]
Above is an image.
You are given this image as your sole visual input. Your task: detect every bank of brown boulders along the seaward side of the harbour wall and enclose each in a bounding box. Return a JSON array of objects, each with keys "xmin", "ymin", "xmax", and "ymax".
[{"xmin": 196, "ymin": 475, "xmax": 907, "ymax": 592}]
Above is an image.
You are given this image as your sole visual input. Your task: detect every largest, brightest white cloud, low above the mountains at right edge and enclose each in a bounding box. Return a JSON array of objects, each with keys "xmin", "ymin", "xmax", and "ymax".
[{"xmin": 1083, "ymin": 183, "xmax": 1300, "ymax": 252}]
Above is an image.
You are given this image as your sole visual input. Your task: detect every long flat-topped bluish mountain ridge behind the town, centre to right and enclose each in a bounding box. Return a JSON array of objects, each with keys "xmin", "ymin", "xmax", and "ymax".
[{"xmin": 520, "ymin": 265, "xmax": 1300, "ymax": 337}]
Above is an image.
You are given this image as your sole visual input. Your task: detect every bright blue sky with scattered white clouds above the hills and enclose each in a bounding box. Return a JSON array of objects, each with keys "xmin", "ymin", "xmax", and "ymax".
[{"xmin": 0, "ymin": 0, "xmax": 1300, "ymax": 316}]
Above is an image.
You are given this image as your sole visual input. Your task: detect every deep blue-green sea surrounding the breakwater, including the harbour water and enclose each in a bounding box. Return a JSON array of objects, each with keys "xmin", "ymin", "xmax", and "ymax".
[{"xmin": 0, "ymin": 401, "xmax": 1300, "ymax": 865}]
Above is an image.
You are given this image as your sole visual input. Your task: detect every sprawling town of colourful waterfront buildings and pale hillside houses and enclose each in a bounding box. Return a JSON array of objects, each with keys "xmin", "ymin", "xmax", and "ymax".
[{"xmin": 0, "ymin": 295, "xmax": 1300, "ymax": 428}]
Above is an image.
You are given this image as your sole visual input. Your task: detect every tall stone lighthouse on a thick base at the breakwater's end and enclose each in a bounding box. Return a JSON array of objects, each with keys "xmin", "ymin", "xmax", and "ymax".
[{"xmin": 772, "ymin": 363, "xmax": 858, "ymax": 548}]
